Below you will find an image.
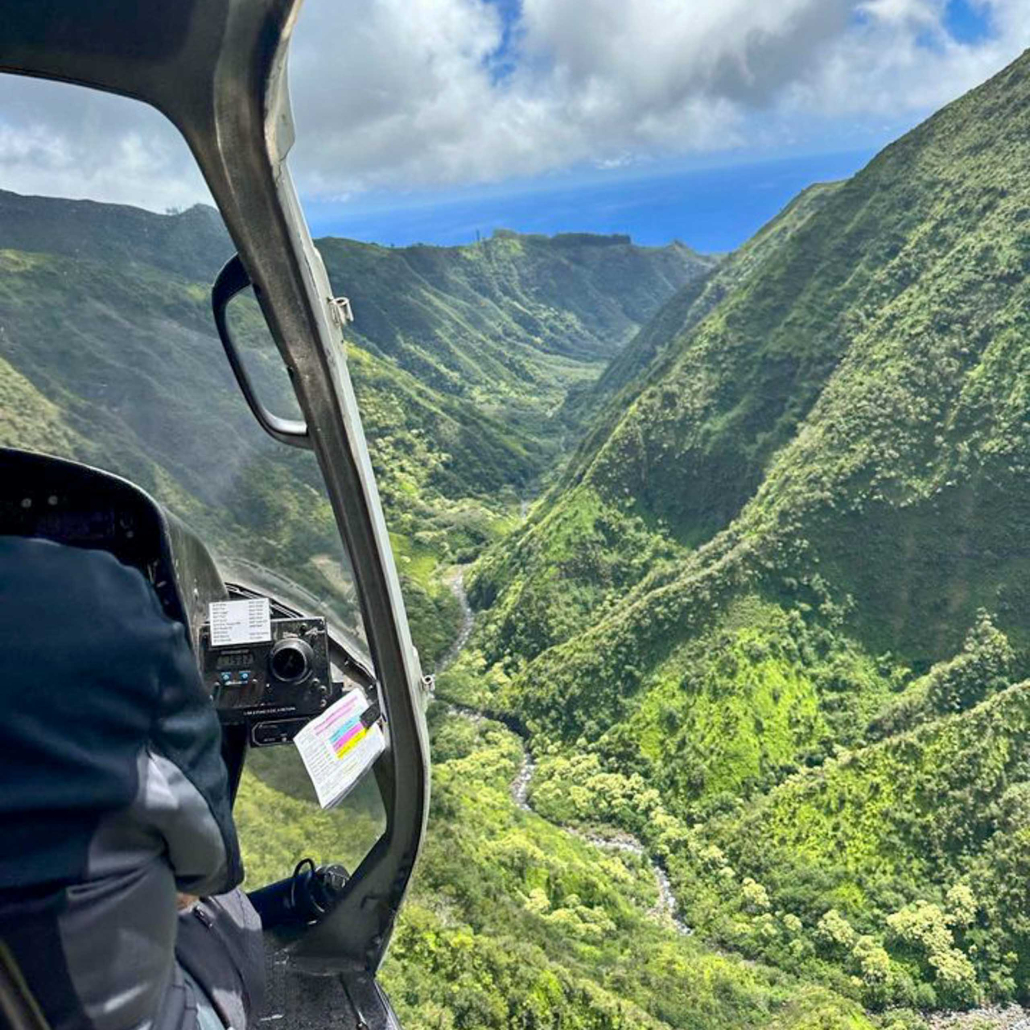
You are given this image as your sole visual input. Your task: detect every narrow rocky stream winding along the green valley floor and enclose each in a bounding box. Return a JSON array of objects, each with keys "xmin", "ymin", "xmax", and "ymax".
[{"xmin": 437, "ymin": 569, "xmax": 693, "ymax": 936}]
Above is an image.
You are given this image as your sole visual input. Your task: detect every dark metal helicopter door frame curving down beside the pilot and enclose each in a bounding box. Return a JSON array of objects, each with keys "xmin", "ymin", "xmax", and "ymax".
[{"xmin": 0, "ymin": 0, "xmax": 430, "ymax": 972}]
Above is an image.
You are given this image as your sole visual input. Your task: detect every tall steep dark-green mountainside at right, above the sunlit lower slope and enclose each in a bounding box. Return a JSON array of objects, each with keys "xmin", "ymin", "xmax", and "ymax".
[{"xmin": 469, "ymin": 46, "xmax": 1030, "ymax": 700}]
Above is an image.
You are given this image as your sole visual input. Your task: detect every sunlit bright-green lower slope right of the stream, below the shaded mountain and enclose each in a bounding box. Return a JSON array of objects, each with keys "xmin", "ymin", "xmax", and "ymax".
[{"xmin": 512, "ymin": 602, "xmax": 1030, "ymax": 1019}]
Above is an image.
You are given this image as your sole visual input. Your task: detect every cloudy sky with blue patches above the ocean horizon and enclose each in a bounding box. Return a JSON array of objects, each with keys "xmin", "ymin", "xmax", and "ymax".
[{"xmin": 0, "ymin": 0, "xmax": 1030, "ymax": 207}]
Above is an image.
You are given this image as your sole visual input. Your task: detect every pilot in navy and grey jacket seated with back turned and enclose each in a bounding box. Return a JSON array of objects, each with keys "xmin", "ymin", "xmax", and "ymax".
[{"xmin": 0, "ymin": 536, "xmax": 264, "ymax": 1030}]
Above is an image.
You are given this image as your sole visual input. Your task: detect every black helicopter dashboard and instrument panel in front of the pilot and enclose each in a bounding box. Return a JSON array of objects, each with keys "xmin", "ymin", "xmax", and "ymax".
[{"xmin": 0, "ymin": 449, "xmax": 352, "ymax": 747}]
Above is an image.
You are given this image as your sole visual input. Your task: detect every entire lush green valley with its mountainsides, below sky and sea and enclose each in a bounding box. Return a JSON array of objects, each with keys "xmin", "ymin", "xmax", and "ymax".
[{"xmin": 6, "ymin": 42, "xmax": 1030, "ymax": 1030}]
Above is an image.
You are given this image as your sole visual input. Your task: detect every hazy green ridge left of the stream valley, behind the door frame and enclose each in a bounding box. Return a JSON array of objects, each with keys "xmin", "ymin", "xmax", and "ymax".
[{"xmin": 0, "ymin": 202, "xmax": 709, "ymax": 662}]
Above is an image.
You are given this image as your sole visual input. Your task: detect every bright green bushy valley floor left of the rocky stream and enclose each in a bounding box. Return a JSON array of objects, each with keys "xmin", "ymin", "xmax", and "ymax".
[{"xmin": 239, "ymin": 706, "xmax": 870, "ymax": 1030}]
